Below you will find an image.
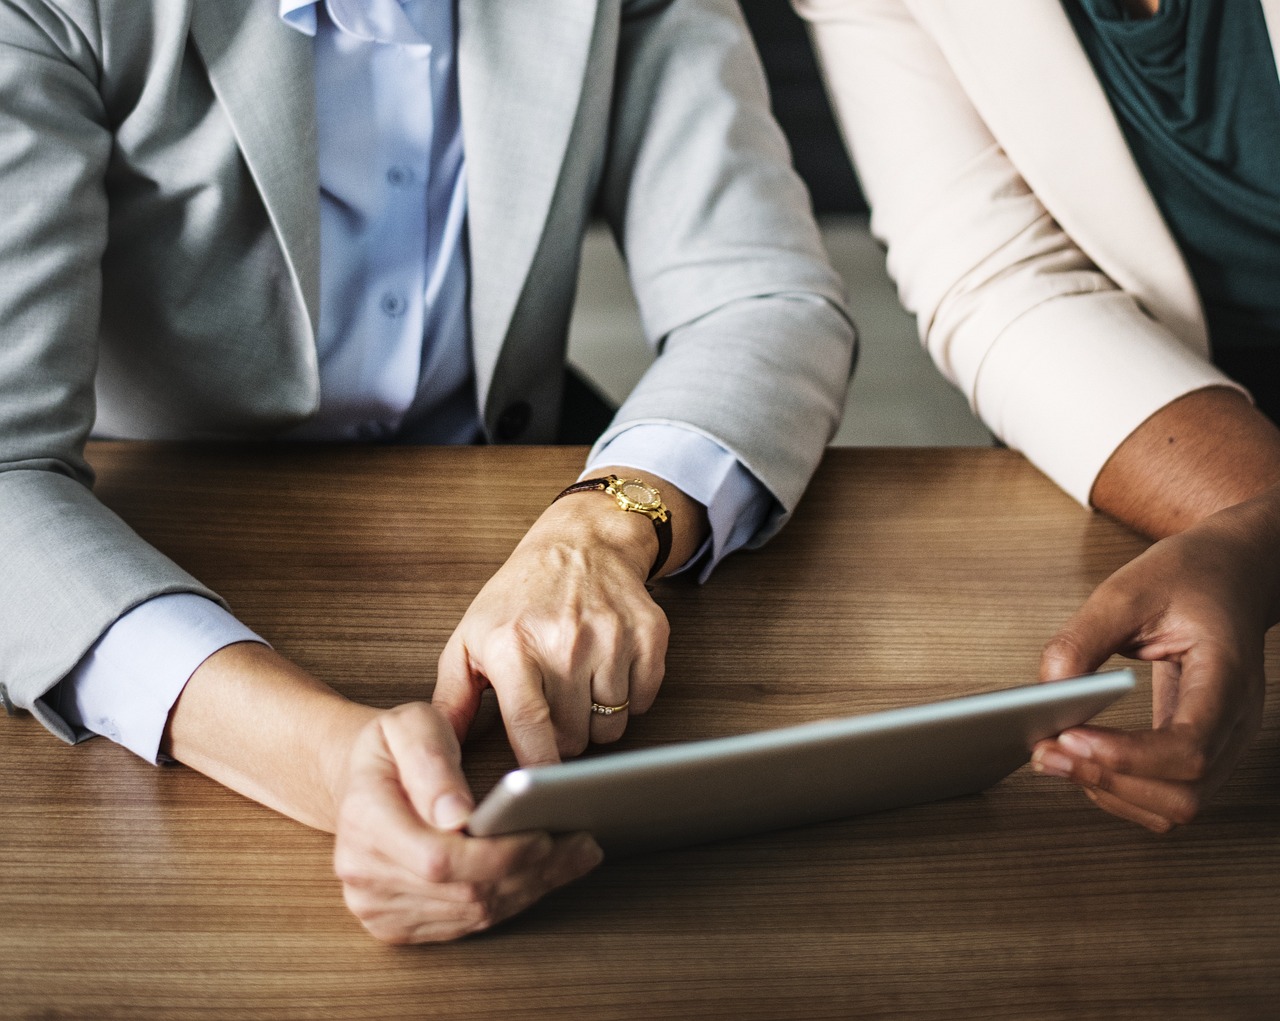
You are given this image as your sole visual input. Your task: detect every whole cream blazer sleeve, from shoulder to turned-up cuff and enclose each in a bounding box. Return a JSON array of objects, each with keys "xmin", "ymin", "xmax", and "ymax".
[{"xmin": 795, "ymin": 0, "xmax": 1235, "ymax": 503}]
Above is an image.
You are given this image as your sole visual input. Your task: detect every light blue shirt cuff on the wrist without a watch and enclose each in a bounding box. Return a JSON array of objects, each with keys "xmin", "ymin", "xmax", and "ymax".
[{"xmin": 50, "ymin": 592, "xmax": 266, "ymax": 763}]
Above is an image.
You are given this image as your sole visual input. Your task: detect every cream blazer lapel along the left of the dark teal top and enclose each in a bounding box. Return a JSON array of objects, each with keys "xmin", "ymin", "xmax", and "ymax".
[{"xmin": 908, "ymin": 0, "xmax": 1208, "ymax": 352}]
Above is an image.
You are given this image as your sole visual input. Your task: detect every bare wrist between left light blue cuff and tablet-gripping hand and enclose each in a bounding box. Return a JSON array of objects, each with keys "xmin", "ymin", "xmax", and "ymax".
[{"xmin": 161, "ymin": 642, "xmax": 378, "ymax": 832}]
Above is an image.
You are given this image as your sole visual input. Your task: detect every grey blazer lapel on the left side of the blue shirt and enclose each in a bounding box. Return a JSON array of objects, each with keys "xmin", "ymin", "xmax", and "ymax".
[{"xmin": 191, "ymin": 0, "xmax": 320, "ymax": 342}]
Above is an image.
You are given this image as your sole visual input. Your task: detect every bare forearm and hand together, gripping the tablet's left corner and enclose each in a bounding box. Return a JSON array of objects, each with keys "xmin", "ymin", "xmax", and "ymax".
[{"xmin": 163, "ymin": 652, "xmax": 600, "ymax": 943}]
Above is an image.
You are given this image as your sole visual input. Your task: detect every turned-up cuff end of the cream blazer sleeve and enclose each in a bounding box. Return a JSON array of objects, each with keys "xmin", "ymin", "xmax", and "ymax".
[{"xmin": 974, "ymin": 292, "xmax": 1247, "ymax": 507}]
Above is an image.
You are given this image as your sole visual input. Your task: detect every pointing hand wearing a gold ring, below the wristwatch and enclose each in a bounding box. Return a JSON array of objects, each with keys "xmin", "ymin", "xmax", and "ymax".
[{"xmin": 433, "ymin": 489, "xmax": 687, "ymax": 765}]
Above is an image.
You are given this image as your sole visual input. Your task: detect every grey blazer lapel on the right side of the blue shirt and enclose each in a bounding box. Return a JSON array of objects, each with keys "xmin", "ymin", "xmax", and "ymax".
[{"xmin": 458, "ymin": 0, "xmax": 598, "ymax": 394}]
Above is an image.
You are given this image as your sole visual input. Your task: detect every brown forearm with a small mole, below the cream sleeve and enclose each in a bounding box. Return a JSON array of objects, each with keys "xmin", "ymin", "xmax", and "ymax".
[{"xmin": 1089, "ymin": 388, "xmax": 1280, "ymax": 539}]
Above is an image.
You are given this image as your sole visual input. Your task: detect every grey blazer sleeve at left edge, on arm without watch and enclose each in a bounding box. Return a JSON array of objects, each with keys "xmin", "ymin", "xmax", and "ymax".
[{"xmin": 0, "ymin": 0, "xmax": 225, "ymax": 740}]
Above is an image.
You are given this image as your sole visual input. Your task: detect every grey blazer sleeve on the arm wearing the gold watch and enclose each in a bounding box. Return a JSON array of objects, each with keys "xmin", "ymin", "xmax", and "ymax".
[{"xmin": 593, "ymin": 0, "xmax": 855, "ymax": 545}]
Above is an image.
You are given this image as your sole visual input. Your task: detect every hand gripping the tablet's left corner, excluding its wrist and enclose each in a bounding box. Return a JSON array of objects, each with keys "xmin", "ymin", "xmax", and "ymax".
[{"xmin": 334, "ymin": 702, "xmax": 602, "ymax": 943}]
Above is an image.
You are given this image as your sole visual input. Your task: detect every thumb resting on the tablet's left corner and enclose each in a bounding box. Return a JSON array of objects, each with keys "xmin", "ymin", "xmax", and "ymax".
[{"xmin": 383, "ymin": 702, "xmax": 475, "ymax": 830}]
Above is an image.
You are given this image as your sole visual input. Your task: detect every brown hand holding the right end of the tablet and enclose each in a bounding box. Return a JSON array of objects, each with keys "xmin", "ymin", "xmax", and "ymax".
[{"xmin": 1032, "ymin": 490, "xmax": 1280, "ymax": 833}]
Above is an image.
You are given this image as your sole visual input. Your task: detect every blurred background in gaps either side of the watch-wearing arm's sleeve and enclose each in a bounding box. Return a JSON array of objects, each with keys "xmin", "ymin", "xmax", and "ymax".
[{"xmin": 570, "ymin": 0, "xmax": 991, "ymax": 447}]
